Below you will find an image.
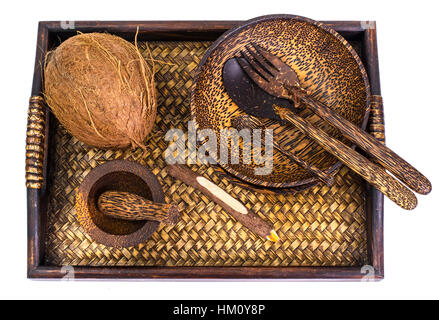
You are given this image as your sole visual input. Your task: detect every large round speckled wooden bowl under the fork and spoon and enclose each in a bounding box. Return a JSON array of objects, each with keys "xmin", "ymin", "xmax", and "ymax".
[{"xmin": 191, "ymin": 15, "xmax": 370, "ymax": 189}]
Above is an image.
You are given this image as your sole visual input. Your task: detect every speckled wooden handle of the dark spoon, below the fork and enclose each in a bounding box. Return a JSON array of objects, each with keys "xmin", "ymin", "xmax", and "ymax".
[{"xmin": 275, "ymin": 106, "xmax": 418, "ymax": 210}]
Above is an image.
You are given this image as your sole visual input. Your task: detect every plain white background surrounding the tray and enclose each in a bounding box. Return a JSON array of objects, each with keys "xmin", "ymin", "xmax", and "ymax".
[{"xmin": 0, "ymin": 0, "xmax": 439, "ymax": 299}]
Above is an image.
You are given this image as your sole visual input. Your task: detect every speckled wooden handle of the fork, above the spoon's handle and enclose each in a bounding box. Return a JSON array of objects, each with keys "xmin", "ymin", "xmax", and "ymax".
[{"xmin": 301, "ymin": 96, "xmax": 431, "ymax": 194}]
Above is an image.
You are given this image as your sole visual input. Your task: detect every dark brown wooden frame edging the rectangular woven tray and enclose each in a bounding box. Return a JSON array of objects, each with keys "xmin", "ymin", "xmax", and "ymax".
[{"xmin": 27, "ymin": 21, "xmax": 384, "ymax": 280}]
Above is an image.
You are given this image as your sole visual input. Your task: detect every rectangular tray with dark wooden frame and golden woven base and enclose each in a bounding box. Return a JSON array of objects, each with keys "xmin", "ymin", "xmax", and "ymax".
[{"xmin": 26, "ymin": 21, "xmax": 384, "ymax": 279}]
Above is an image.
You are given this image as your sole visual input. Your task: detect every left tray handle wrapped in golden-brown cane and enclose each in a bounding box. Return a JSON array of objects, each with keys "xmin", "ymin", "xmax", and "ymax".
[{"xmin": 26, "ymin": 96, "xmax": 46, "ymax": 189}]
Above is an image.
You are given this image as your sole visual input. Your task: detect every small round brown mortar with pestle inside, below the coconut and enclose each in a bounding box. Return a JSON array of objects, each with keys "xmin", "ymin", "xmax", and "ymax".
[{"xmin": 76, "ymin": 160, "xmax": 165, "ymax": 247}]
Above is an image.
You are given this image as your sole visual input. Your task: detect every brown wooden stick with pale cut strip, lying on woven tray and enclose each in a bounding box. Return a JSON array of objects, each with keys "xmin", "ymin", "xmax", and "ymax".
[{"xmin": 166, "ymin": 164, "xmax": 279, "ymax": 242}]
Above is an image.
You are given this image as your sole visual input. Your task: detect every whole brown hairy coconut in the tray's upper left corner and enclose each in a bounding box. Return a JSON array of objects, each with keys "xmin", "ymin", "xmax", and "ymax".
[{"xmin": 44, "ymin": 33, "xmax": 156, "ymax": 148}]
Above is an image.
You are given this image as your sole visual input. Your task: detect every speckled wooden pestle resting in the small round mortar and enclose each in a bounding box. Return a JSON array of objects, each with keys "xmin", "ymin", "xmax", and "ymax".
[{"xmin": 98, "ymin": 191, "xmax": 180, "ymax": 225}]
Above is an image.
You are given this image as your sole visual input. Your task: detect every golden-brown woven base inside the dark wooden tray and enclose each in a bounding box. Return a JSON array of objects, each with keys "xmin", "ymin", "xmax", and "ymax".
[{"xmin": 45, "ymin": 42, "xmax": 367, "ymax": 266}]
